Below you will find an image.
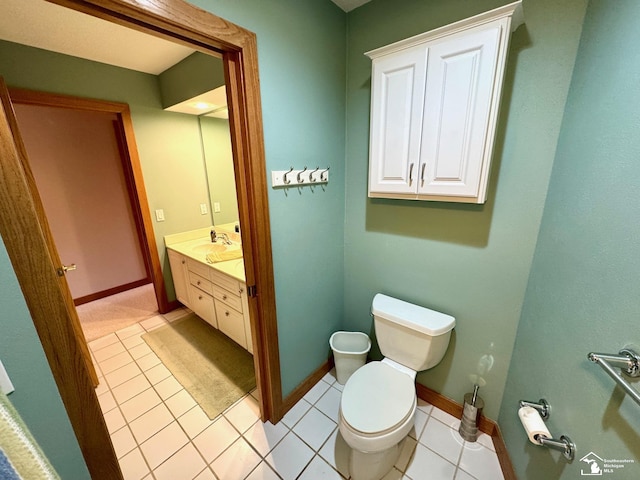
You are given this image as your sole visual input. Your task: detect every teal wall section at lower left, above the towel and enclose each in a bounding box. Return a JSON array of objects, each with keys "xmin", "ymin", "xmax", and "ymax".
[{"xmin": 0, "ymin": 239, "xmax": 91, "ymax": 480}]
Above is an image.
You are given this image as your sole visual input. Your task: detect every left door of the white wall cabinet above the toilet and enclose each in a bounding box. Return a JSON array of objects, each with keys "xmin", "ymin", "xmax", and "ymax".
[{"xmin": 369, "ymin": 45, "xmax": 427, "ymax": 196}]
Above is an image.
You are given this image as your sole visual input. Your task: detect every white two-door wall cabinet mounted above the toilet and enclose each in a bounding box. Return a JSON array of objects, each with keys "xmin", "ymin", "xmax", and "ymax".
[{"xmin": 367, "ymin": 2, "xmax": 523, "ymax": 203}]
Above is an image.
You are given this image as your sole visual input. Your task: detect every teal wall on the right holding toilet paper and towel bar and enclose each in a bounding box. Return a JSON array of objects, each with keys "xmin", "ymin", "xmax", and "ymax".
[{"xmin": 499, "ymin": 0, "xmax": 640, "ymax": 480}]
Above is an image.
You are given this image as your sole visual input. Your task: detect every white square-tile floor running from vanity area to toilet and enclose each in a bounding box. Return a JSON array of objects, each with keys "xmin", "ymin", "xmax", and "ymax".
[{"xmin": 89, "ymin": 311, "xmax": 503, "ymax": 480}]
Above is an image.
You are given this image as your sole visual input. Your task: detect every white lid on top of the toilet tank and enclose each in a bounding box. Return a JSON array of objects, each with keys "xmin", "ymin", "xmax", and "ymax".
[{"xmin": 371, "ymin": 293, "xmax": 456, "ymax": 336}]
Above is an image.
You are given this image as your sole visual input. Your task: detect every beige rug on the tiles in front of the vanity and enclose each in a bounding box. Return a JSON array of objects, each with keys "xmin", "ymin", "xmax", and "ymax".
[{"xmin": 142, "ymin": 314, "xmax": 256, "ymax": 420}]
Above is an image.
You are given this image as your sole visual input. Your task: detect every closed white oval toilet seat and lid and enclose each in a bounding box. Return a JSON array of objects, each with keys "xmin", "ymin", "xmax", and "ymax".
[{"xmin": 340, "ymin": 362, "xmax": 416, "ymax": 437}]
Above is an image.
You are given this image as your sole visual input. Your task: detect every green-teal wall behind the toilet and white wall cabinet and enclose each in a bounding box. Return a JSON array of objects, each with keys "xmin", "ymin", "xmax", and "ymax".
[{"xmin": 344, "ymin": 0, "xmax": 585, "ymax": 419}]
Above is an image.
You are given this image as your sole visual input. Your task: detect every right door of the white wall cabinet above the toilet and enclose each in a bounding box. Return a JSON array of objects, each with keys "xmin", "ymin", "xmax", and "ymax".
[{"xmin": 418, "ymin": 22, "xmax": 504, "ymax": 201}]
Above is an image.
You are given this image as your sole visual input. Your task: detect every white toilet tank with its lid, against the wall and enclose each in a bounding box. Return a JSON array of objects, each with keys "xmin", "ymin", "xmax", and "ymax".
[{"xmin": 371, "ymin": 293, "xmax": 456, "ymax": 372}]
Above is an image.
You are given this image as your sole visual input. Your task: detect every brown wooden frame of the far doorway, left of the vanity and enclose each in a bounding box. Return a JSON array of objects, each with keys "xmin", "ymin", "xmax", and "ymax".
[{"xmin": 9, "ymin": 87, "xmax": 171, "ymax": 313}]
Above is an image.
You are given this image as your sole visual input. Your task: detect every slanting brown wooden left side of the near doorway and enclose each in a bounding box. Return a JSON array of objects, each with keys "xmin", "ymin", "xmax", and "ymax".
[{"xmin": 0, "ymin": 77, "xmax": 122, "ymax": 480}]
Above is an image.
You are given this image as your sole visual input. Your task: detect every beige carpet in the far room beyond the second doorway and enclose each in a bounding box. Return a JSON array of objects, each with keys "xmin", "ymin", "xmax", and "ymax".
[{"xmin": 76, "ymin": 283, "xmax": 158, "ymax": 342}]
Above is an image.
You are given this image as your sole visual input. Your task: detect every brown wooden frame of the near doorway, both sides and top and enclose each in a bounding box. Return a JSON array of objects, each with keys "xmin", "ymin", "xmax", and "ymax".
[{"xmin": 0, "ymin": 0, "xmax": 283, "ymax": 480}]
